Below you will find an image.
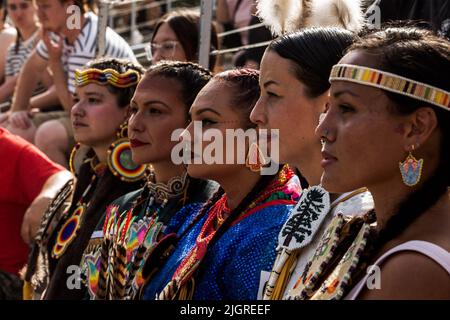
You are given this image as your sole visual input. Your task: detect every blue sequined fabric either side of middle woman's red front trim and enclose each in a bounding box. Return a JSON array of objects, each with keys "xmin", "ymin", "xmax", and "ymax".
[{"xmin": 142, "ymin": 166, "xmax": 301, "ymax": 300}]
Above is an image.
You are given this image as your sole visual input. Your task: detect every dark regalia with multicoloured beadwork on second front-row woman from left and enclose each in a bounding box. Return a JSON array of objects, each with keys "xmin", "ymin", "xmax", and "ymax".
[{"xmin": 80, "ymin": 176, "xmax": 218, "ymax": 300}]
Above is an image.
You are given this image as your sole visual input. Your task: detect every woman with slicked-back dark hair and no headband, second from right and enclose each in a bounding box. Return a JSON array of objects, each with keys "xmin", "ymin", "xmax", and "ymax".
[{"xmin": 250, "ymin": 28, "xmax": 373, "ymax": 300}]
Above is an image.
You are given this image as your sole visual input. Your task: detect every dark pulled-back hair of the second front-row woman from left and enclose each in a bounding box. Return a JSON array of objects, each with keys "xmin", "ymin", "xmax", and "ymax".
[{"xmin": 144, "ymin": 61, "xmax": 212, "ymax": 115}]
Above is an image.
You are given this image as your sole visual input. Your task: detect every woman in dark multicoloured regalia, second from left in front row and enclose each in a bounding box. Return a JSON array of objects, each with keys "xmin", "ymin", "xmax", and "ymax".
[{"xmin": 81, "ymin": 61, "xmax": 218, "ymax": 299}]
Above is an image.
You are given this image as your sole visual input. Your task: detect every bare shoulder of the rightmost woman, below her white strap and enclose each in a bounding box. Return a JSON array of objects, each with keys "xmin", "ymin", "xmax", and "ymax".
[{"xmin": 358, "ymin": 251, "xmax": 450, "ymax": 300}]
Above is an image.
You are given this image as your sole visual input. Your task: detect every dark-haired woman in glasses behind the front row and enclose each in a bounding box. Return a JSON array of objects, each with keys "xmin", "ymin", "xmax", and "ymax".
[{"xmin": 147, "ymin": 10, "xmax": 219, "ymax": 70}]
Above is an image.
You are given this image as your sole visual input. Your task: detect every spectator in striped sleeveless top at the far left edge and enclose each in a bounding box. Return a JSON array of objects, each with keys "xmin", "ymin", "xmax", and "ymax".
[{"xmin": 0, "ymin": 0, "xmax": 51, "ymax": 102}]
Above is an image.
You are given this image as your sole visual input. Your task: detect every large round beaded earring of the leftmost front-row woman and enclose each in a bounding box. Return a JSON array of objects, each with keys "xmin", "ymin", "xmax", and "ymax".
[{"xmin": 107, "ymin": 123, "xmax": 147, "ymax": 182}]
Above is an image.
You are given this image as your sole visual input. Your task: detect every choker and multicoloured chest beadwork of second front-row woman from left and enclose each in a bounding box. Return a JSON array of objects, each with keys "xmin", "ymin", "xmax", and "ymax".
[{"xmin": 96, "ymin": 173, "xmax": 189, "ymax": 299}]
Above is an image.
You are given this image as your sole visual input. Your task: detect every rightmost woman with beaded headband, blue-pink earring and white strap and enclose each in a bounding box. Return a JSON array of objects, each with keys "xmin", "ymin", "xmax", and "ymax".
[{"xmin": 308, "ymin": 27, "xmax": 450, "ymax": 299}]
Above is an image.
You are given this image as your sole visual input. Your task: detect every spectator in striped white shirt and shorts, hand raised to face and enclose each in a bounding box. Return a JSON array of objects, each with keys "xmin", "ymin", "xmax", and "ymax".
[{"xmin": 2, "ymin": 0, "xmax": 136, "ymax": 166}]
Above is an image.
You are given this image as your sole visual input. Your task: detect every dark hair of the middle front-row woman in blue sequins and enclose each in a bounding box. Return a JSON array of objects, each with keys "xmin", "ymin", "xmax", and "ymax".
[{"xmin": 213, "ymin": 68, "xmax": 261, "ymax": 127}]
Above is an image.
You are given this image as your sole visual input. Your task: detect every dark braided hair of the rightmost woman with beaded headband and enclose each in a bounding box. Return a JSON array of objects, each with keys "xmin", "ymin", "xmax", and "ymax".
[{"xmin": 348, "ymin": 27, "xmax": 450, "ymax": 248}]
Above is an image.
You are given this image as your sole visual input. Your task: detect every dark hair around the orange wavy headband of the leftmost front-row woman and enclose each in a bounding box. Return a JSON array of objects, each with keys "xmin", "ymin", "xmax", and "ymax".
[{"xmin": 85, "ymin": 58, "xmax": 145, "ymax": 108}]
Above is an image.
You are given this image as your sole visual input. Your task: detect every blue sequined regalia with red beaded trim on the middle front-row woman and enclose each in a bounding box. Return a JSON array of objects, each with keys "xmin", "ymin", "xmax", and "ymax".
[{"xmin": 143, "ymin": 166, "xmax": 300, "ymax": 300}]
